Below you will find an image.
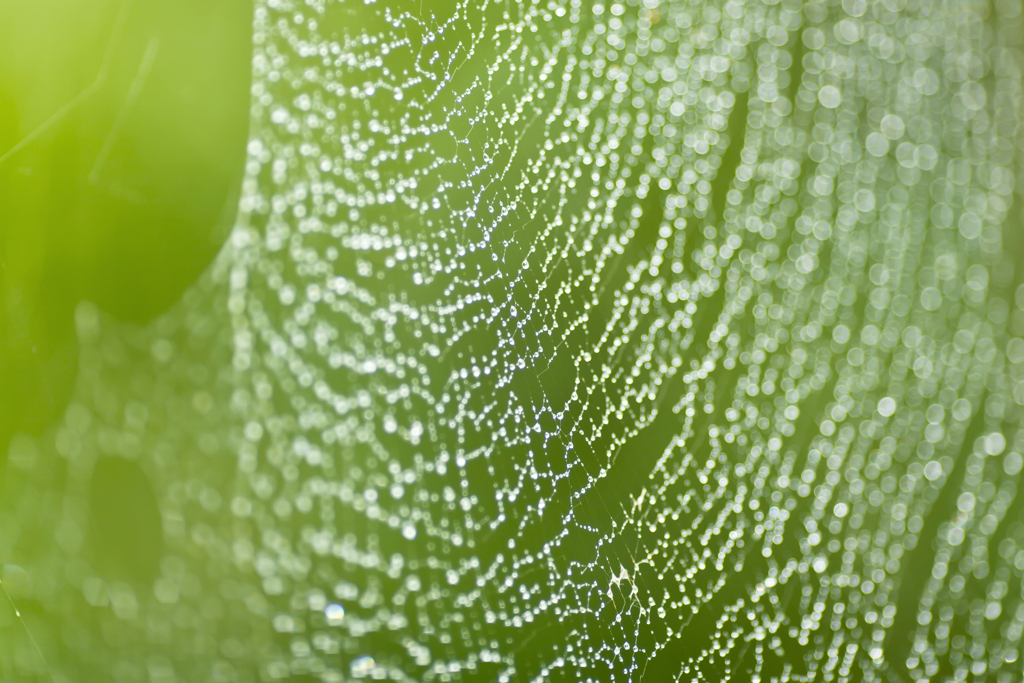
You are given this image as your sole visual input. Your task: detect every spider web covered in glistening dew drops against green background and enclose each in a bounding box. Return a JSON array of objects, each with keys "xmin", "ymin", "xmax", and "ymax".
[{"xmin": 0, "ymin": 0, "xmax": 1024, "ymax": 683}]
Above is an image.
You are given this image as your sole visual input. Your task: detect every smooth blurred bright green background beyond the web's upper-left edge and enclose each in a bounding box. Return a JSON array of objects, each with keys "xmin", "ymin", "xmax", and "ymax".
[{"xmin": 0, "ymin": 0, "xmax": 252, "ymax": 454}]
